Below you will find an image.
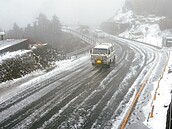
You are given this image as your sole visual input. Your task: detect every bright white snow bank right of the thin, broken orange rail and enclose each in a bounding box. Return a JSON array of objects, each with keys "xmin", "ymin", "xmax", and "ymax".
[{"xmin": 145, "ymin": 52, "xmax": 172, "ymax": 129}]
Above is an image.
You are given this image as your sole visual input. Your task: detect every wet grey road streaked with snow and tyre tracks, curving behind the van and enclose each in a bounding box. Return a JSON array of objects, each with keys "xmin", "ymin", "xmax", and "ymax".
[{"xmin": 0, "ymin": 36, "xmax": 167, "ymax": 129}]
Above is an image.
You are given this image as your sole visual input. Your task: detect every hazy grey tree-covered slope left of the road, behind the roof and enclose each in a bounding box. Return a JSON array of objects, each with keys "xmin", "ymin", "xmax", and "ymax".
[{"xmin": 6, "ymin": 13, "xmax": 85, "ymax": 53}]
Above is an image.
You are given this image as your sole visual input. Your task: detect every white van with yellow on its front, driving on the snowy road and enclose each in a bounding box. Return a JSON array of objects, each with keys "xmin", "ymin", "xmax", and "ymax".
[{"xmin": 91, "ymin": 43, "xmax": 115, "ymax": 67}]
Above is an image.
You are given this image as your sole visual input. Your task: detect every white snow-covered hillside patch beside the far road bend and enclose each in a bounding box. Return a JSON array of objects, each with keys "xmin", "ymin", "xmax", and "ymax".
[{"xmin": 111, "ymin": 10, "xmax": 172, "ymax": 47}]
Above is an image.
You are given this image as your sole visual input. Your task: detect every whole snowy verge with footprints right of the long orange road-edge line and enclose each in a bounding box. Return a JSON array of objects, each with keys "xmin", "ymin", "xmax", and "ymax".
[{"xmin": 123, "ymin": 50, "xmax": 172, "ymax": 129}]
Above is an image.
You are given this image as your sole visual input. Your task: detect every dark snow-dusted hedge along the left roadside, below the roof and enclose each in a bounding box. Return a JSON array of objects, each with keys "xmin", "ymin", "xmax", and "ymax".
[{"xmin": 0, "ymin": 45, "xmax": 65, "ymax": 83}]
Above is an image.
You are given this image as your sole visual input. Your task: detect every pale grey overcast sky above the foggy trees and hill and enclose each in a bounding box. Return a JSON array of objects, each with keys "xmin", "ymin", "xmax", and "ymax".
[{"xmin": 0, "ymin": 0, "xmax": 125, "ymax": 30}]
